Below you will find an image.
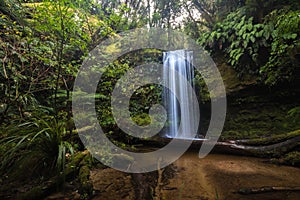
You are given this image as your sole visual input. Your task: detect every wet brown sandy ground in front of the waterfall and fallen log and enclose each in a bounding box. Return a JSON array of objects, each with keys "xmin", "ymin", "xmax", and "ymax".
[{"xmin": 91, "ymin": 152, "xmax": 300, "ymax": 200}]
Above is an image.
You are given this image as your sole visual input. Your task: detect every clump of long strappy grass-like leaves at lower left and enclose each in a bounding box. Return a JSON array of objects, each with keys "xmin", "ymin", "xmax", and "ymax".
[{"xmin": 0, "ymin": 112, "xmax": 74, "ymax": 176}]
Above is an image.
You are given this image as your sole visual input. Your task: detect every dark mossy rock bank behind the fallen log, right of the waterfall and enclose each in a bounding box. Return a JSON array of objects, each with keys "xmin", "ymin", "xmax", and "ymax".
[{"xmin": 222, "ymin": 91, "xmax": 300, "ymax": 140}]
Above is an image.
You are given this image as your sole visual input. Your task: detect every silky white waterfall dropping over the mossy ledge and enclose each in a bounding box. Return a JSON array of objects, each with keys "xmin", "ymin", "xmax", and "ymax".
[{"xmin": 163, "ymin": 50, "xmax": 198, "ymax": 139}]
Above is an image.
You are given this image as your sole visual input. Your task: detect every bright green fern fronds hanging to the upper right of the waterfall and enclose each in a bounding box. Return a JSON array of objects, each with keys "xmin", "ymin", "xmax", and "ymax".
[{"xmin": 198, "ymin": 10, "xmax": 271, "ymax": 77}]
